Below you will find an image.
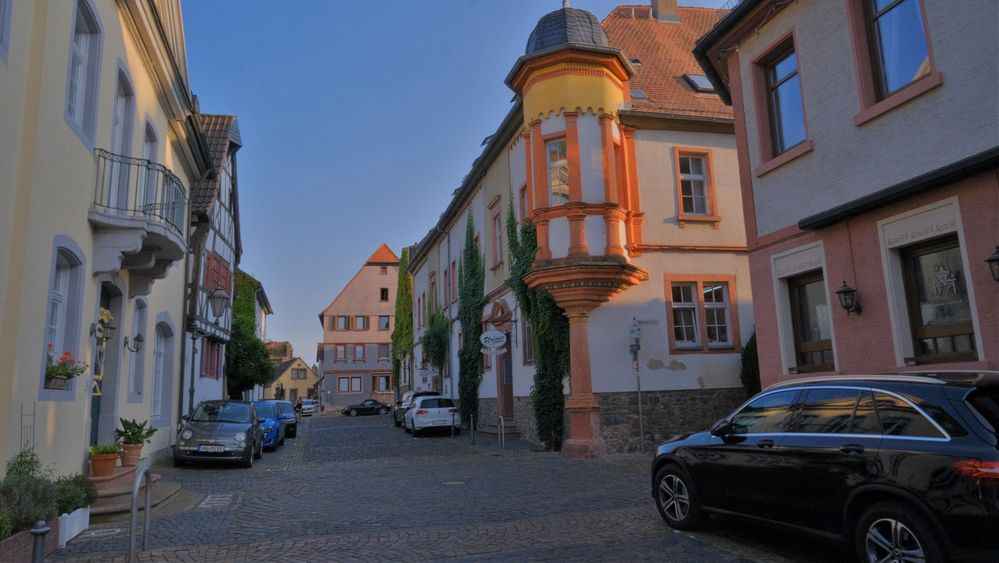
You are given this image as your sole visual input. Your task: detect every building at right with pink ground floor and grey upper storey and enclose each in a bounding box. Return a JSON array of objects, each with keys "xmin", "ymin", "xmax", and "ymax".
[{"xmin": 695, "ymin": 0, "xmax": 999, "ymax": 385}]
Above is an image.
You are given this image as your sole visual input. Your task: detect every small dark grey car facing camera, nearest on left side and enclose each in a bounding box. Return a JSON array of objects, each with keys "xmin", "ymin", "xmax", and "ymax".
[{"xmin": 173, "ymin": 401, "xmax": 264, "ymax": 467}]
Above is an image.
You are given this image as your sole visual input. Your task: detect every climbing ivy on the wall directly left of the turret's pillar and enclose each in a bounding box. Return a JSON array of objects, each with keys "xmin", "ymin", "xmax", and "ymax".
[{"xmin": 506, "ymin": 197, "xmax": 569, "ymax": 450}]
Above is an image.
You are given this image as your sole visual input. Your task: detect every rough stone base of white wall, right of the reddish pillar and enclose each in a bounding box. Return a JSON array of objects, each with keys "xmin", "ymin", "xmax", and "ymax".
[{"xmin": 597, "ymin": 387, "xmax": 747, "ymax": 453}]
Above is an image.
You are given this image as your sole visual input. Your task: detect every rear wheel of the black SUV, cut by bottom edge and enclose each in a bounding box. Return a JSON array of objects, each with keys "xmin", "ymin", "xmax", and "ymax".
[{"xmin": 854, "ymin": 502, "xmax": 946, "ymax": 563}]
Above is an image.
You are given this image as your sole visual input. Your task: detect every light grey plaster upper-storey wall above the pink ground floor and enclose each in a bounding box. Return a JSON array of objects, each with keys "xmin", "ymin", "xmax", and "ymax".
[{"xmin": 732, "ymin": 0, "xmax": 999, "ymax": 235}]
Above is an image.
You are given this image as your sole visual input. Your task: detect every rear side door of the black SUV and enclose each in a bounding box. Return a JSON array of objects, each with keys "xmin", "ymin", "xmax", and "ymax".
[{"xmin": 779, "ymin": 388, "xmax": 881, "ymax": 531}]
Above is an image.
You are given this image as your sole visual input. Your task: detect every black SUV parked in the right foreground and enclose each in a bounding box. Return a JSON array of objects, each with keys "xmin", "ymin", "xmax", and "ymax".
[{"xmin": 652, "ymin": 372, "xmax": 999, "ymax": 562}]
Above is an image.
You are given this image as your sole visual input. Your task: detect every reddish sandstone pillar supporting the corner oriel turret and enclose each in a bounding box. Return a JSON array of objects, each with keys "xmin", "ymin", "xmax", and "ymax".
[{"xmin": 562, "ymin": 309, "xmax": 607, "ymax": 457}]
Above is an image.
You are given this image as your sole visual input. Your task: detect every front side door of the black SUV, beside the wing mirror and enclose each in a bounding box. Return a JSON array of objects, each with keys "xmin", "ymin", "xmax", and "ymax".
[{"xmin": 690, "ymin": 389, "xmax": 798, "ymax": 518}]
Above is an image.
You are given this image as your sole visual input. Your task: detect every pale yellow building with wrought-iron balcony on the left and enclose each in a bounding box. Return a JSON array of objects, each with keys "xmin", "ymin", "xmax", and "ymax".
[{"xmin": 0, "ymin": 0, "xmax": 210, "ymax": 473}]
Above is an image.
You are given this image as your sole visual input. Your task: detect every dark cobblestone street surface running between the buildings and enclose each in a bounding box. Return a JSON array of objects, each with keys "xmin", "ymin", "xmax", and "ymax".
[{"xmin": 55, "ymin": 416, "xmax": 848, "ymax": 562}]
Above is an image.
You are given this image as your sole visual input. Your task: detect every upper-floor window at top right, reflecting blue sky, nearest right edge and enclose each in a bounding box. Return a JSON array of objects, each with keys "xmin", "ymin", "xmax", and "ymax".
[{"xmin": 866, "ymin": 0, "xmax": 932, "ymax": 100}]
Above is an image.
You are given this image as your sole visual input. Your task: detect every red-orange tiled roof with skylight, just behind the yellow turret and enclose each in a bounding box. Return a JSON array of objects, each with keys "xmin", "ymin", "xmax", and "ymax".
[{"xmin": 602, "ymin": 5, "xmax": 732, "ymax": 119}]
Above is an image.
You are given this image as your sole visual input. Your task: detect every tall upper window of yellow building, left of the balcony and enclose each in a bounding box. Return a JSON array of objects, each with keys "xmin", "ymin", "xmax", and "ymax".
[{"xmin": 66, "ymin": 0, "xmax": 101, "ymax": 145}]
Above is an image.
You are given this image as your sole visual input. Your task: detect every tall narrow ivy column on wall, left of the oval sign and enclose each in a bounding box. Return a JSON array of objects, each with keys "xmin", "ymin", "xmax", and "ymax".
[{"xmin": 458, "ymin": 218, "xmax": 486, "ymax": 426}]
